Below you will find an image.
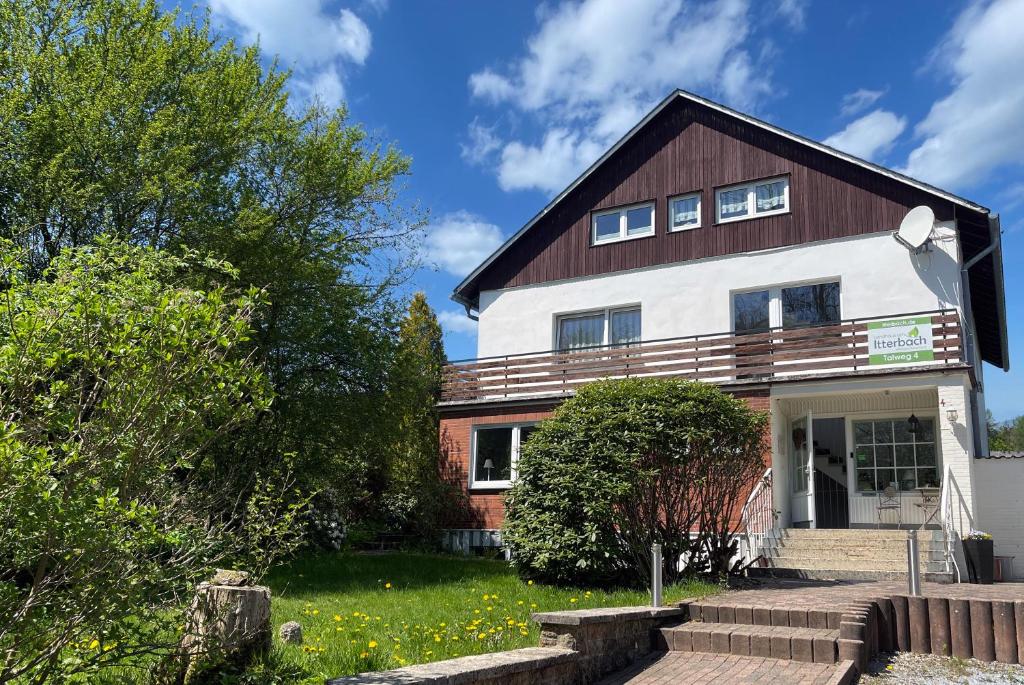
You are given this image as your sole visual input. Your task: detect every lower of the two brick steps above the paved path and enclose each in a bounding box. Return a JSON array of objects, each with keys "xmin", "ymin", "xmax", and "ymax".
[{"xmin": 658, "ymin": 622, "xmax": 839, "ymax": 663}]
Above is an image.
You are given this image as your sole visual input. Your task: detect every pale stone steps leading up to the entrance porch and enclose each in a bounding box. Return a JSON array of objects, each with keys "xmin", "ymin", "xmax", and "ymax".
[{"xmin": 748, "ymin": 528, "xmax": 952, "ymax": 583}]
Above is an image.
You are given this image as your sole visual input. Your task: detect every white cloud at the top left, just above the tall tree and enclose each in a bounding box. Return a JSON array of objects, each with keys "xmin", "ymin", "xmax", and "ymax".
[{"xmin": 209, "ymin": 0, "xmax": 373, "ymax": 106}]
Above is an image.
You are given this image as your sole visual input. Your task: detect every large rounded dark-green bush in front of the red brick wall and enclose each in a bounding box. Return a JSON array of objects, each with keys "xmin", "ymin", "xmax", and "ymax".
[{"xmin": 503, "ymin": 379, "xmax": 768, "ymax": 585}]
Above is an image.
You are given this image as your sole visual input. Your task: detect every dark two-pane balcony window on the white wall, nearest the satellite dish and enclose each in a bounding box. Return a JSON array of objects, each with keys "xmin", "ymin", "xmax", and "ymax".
[{"xmin": 732, "ymin": 281, "xmax": 842, "ymax": 334}]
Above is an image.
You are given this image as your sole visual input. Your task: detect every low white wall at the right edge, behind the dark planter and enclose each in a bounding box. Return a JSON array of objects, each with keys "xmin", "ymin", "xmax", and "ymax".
[{"xmin": 975, "ymin": 459, "xmax": 1024, "ymax": 580}]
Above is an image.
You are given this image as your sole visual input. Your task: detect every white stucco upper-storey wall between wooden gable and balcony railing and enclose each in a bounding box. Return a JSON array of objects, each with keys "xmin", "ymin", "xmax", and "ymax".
[{"xmin": 477, "ymin": 224, "xmax": 961, "ymax": 356}]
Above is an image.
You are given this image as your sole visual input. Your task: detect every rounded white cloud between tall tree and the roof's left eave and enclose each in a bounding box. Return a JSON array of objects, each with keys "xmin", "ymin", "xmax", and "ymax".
[{"xmin": 424, "ymin": 211, "xmax": 504, "ymax": 276}]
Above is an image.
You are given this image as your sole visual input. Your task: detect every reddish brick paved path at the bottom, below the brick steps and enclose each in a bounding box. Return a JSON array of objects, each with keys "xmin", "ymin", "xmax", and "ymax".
[{"xmin": 599, "ymin": 652, "xmax": 853, "ymax": 685}]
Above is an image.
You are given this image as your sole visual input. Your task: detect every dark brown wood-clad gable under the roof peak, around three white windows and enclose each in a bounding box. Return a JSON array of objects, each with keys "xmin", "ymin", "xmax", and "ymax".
[{"xmin": 462, "ymin": 98, "xmax": 984, "ymax": 299}]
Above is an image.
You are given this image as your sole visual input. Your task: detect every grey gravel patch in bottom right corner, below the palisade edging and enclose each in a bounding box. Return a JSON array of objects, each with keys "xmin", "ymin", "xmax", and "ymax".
[{"xmin": 859, "ymin": 653, "xmax": 1024, "ymax": 685}]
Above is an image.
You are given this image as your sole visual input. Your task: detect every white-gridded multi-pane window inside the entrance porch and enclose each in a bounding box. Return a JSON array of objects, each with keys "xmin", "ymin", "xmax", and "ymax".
[{"xmin": 853, "ymin": 418, "xmax": 939, "ymax": 493}]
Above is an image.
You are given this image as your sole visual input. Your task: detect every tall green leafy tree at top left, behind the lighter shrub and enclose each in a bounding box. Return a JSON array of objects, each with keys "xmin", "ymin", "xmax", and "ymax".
[{"xmin": 0, "ymin": 0, "xmax": 422, "ymax": 528}]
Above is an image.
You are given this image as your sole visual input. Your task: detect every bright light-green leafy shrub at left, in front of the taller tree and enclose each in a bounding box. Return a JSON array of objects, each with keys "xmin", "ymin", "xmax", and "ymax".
[{"xmin": 0, "ymin": 239, "xmax": 298, "ymax": 683}]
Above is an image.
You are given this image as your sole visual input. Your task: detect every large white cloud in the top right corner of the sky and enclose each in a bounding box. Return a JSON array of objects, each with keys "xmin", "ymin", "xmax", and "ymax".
[{"xmin": 904, "ymin": 0, "xmax": 1024, "ymax": 188}]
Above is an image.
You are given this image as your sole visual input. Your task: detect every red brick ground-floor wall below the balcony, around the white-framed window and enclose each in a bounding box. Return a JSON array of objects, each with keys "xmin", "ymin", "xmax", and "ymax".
[{"xmin": 440, "ymin": 389, "xmax": 771, "ymax": 528}]
